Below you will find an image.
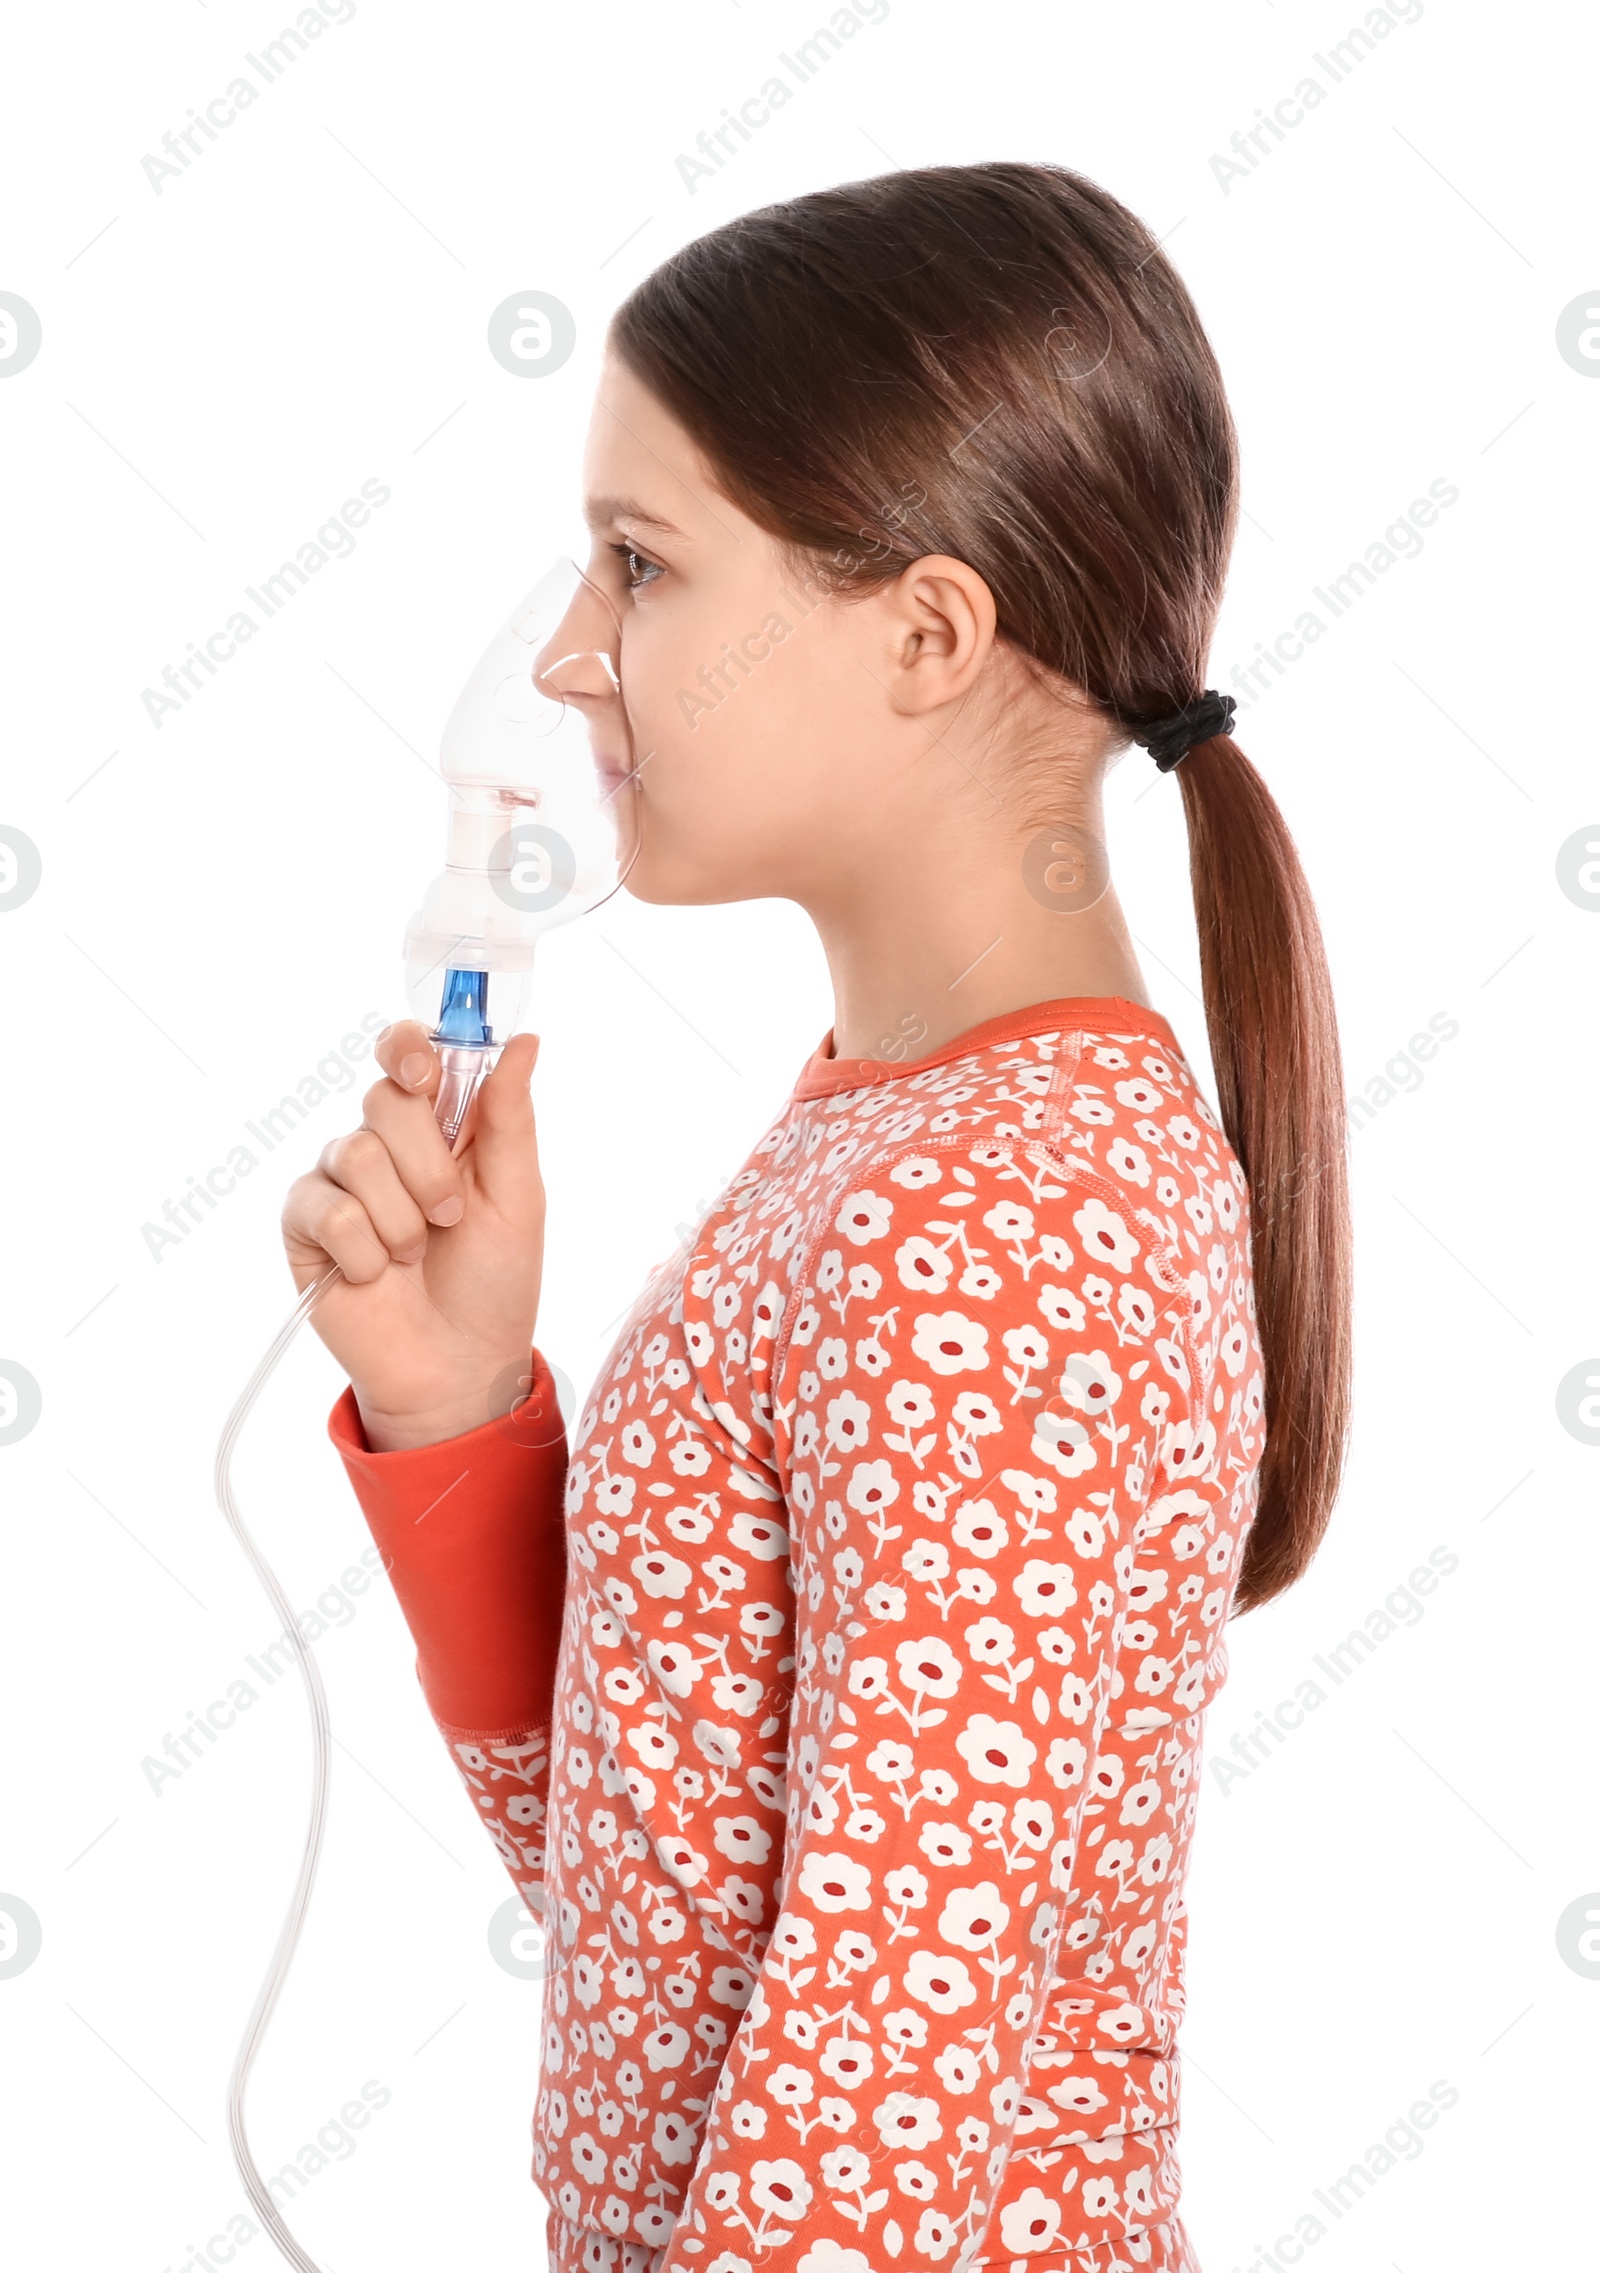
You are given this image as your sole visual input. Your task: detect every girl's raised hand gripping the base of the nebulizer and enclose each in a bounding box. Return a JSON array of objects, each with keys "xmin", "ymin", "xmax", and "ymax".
[{"xmin": 284, "ymin": 1018, "xmax": 545, "ymax": 1452}]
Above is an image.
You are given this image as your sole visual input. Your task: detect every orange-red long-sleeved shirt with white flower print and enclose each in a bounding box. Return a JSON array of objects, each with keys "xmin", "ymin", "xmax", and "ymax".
[{"xmin": 330, "ymin": 998, "xmax": 1264, "ymax": 2273}]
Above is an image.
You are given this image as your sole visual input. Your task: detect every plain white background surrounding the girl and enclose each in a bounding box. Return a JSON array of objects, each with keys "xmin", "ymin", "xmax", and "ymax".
[{"xmin": 0, "ymin": 0, "xmax": 1600, "ymax": 2273}]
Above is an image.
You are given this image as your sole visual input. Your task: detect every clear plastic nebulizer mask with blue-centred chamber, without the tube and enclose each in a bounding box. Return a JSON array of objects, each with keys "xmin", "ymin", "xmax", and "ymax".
[{"xmin": 405, "ymin": 559, "xmax": 639, "ymax": 1143}]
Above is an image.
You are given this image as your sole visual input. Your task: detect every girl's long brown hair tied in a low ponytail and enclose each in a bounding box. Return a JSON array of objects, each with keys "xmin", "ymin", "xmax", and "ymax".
[{"xmin": 611, "ymin": 164, "xmax": 1350, "ymax": 1612}]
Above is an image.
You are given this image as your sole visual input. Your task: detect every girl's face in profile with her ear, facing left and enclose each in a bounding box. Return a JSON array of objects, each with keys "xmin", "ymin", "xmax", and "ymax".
[{"xmin": 543, "ymin": 357, "xmax": 1013, "ymax": 907}]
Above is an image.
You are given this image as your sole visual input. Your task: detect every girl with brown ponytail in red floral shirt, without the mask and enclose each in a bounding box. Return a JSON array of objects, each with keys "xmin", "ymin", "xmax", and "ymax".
[{"xmin": 286, "ymin": 164, "xmax": 1350, "ymax": 2273}]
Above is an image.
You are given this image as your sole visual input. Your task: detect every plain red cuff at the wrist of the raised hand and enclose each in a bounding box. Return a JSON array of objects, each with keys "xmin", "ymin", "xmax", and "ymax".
[{"xmin": 327, "ymin": 1350, "xmax": 566, "ymax": 1734}]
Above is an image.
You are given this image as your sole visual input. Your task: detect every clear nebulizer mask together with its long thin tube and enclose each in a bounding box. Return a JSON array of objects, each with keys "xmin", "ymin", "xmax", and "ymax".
[{"xmin": 216, "ymin": 557, "xmax": 641, "ymax": 2273}]
